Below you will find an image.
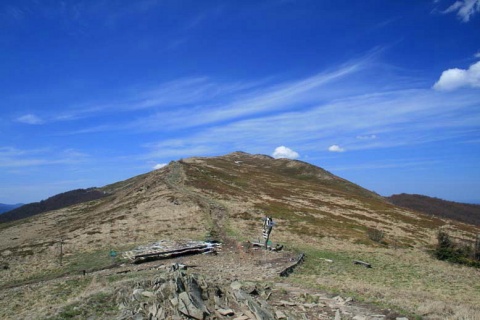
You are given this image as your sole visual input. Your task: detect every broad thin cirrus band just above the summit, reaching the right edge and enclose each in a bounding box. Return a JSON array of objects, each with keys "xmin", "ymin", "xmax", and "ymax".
[{"xmin": 141, "ymin": 83, "xmax": 480, "ymax": 157}]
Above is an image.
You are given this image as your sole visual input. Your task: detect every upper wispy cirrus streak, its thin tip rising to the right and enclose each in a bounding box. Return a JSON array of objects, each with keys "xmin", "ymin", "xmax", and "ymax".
[{"xmin": 55, "ymin": 51, "xmax": 376, "ymax": 134}]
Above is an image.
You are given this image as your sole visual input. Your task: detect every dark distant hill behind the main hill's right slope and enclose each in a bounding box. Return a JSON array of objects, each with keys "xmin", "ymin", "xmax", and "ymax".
[{"xmin": 386, "ymin": 193, "xmax": 480, "ymax": 226}]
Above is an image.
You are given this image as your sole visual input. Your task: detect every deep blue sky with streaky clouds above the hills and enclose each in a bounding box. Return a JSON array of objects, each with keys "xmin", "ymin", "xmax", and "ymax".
[{"xmin": 0, "ymin": 0, "xmax": 480, "ymax": 203}]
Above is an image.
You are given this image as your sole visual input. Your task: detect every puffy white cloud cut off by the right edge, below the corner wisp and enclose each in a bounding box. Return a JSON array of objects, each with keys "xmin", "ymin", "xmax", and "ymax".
[{"xmin": 433, "ymin": 60, "xmax": 480, "ymax": 91}]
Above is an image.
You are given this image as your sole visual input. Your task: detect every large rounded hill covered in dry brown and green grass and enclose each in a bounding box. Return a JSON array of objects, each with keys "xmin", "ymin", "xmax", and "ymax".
[{"xmin": 0, "ymin": 152, "xmax": 480, "ymax": 319}]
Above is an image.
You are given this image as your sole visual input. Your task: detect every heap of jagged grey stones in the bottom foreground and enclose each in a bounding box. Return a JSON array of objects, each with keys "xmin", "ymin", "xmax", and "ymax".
[{"xmin": 117, "ymin": 270, "xmax": 276, "ymax": 320}]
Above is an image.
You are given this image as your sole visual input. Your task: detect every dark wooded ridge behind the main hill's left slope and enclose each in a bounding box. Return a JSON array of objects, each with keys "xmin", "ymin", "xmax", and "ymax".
[{"xmin": 0, "ymin": 188, "xmax": 108, "ymax": 223}]
